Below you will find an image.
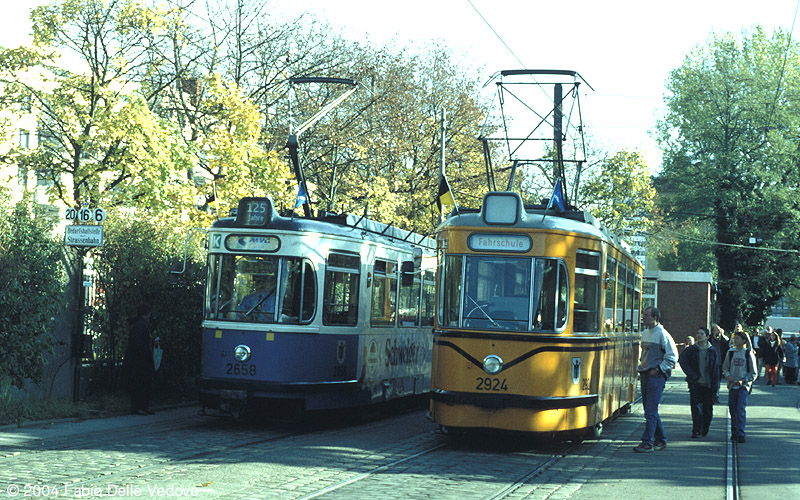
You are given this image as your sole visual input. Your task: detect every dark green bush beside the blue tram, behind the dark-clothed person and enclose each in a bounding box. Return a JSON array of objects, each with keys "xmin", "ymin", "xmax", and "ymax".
[{"xmin": 92, "ymin": 214, "xmax": 205, "ymax": 390}]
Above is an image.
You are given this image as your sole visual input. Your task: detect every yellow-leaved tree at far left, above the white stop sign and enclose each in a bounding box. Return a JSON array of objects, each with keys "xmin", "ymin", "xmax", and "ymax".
[{"xmin": 0, "ymin": 0, "xmax": 192, "ymax": 210}]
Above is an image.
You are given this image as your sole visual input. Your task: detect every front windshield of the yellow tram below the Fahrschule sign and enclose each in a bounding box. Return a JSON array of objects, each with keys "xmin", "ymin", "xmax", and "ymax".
[{"xmin": 439, "ymin": 255, "xmax": 569, "ymax": 331}]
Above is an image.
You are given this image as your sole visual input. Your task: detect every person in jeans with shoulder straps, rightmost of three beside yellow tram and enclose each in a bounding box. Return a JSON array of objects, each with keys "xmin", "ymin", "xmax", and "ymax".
[{"xmin": 722, "ymin": 332, "xmax": 756, "ymax": 443}]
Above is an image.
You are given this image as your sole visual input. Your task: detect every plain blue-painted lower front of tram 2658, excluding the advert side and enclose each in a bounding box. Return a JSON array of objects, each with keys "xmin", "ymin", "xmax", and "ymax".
[{"xmin": 198, "ymin": 328, "xmax": 370, "ymax": 410}]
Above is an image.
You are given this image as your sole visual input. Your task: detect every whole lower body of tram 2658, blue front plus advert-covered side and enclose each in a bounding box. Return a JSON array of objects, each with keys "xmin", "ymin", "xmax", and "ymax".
[{"xmin": 198, "ymin": 328, "xmax": 431, "ymax": 410}]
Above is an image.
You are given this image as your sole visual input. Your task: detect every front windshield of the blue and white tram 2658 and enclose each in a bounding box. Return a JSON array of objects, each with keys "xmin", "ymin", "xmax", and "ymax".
[{"xmin": 205, "ymin": 255, "xmax": 316, "ymax": 323}]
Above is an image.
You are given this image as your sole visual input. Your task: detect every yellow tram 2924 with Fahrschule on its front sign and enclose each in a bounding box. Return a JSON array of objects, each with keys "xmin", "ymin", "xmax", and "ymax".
[{"xmin": 430, "ymin": 191, "xmax": 642, "ymax": 436}]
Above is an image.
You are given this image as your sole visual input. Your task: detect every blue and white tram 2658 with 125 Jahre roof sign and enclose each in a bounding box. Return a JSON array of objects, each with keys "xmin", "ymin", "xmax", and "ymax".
[{"xmin": 198, "ymin": 198, "xmax": 435, "ymax": 413}]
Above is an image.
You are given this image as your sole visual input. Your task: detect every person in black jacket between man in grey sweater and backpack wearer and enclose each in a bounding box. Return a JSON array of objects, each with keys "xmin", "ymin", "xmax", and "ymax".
[{"xmin": 678, "ymin": 327, "xmax": 720, "ymax": 438}]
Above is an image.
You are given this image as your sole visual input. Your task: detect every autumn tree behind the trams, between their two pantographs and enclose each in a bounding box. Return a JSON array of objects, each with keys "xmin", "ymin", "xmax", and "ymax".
[{"xmin": 288, "ymin": 44, "xmax": 486, "ymax": 233}]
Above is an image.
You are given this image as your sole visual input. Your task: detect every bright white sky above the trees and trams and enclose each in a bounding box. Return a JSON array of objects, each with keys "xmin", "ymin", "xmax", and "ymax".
[{"xmin": 0, "ymin": 0, "xmax": 800, "ymax": 171}]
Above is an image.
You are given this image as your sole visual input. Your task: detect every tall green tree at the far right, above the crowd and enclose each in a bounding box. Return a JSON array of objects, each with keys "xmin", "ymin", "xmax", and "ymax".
[{"xmin": 658, "ymin": 27, "xmax": 800, "ymax": 328}]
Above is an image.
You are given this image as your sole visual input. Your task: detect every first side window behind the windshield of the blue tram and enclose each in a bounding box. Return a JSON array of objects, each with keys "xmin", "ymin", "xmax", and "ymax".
[{"xmin": 322, "ymin": 253, "xmax": 361, "ymax": 326}]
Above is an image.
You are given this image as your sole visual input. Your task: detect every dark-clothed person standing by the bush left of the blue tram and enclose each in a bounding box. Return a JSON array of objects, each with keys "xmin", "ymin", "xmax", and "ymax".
[{"xmin": 125, "ymin": 303, "xmax": 155, "ymax": 415}]
